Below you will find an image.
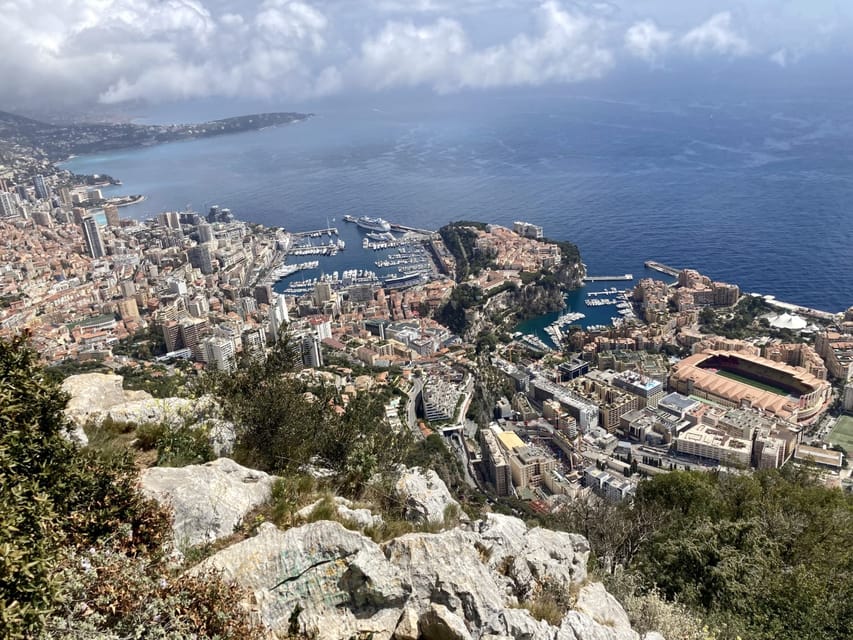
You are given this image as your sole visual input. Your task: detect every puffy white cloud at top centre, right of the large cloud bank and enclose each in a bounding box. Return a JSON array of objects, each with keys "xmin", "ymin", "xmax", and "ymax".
[{"xmin": 352, "ymin": 1, "xmax": 613, "ymax": 92}]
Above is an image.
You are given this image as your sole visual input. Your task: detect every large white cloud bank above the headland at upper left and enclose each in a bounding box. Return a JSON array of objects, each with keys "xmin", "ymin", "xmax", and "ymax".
[{"xmin": 0, "ymin": 0, "xmax": 339, "ymax": 106}]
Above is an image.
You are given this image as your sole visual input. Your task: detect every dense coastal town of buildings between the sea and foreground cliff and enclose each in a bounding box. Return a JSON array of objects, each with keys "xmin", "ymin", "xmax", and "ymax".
[{"xmin": 5, "ymin": 165, "xmax": 853, "ymax": 512}]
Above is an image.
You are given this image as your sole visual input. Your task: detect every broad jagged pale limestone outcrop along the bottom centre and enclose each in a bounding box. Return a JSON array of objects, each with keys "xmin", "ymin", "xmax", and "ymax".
[{"xmin": 192, "ymin": 515, "xmax": 656, "ymax": 640}]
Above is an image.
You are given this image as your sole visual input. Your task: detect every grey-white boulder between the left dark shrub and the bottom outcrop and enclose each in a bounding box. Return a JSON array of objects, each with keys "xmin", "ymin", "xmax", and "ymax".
[{"xmin": 140, "ymin": 458, "xmax": 275, "ymax": 546}]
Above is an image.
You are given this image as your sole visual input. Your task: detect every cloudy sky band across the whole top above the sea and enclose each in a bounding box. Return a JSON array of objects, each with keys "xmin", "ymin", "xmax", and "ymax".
[{"xmin": 0, "ymin": 0, "xmax": 853, "ymax": 109}]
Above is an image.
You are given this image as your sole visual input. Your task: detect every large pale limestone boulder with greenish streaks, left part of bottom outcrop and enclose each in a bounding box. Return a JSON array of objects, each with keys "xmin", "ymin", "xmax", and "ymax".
[{"xmin": 192, "ymin": 521, "xmax": 409, "ymax": 640}]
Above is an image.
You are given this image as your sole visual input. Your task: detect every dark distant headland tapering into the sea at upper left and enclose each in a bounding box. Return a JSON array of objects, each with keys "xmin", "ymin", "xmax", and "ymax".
[{"xmin": 0, "ymin": 111, "xmax": 312, "ymax": 162}]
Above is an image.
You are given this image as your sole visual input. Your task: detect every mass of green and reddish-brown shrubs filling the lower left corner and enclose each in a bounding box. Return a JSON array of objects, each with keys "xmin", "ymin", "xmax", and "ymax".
[{"xmin": 0, "ymin": 338, "xmax": 260, "ymax": 640}]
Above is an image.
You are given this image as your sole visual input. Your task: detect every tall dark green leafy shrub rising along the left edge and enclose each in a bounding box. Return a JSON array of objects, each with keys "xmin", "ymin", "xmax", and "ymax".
[{"xmin": 0, "ymin": 338, "xmax": 188, "ymax": 639}]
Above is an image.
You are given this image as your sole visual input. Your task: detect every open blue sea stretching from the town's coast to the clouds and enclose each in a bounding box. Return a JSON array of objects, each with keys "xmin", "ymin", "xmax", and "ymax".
[{"xmin": 65, "ymin": 91, "xmax": 853, "ymax": 322}]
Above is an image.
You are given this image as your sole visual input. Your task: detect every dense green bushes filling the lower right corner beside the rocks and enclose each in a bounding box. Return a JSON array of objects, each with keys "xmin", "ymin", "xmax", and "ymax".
[{"xmin": 548, "ymin": 470, "xmax": 853, "ymax": 640}]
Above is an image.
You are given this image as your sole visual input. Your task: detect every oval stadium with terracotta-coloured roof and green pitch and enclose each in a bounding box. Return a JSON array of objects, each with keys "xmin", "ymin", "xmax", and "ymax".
[{"xmin": 669, "ymin": 350, "xmax": 830, "ymax": 423}]
